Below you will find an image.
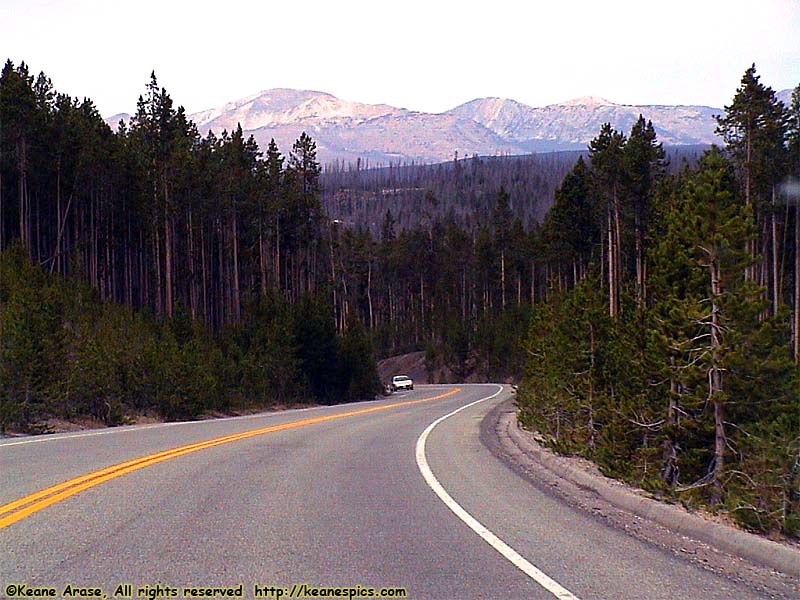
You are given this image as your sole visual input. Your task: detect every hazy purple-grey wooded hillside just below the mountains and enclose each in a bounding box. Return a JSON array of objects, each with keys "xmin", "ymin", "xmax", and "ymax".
[{"xmin": 321, "ymin": 145, "xmax": 707, "ymax": 235}]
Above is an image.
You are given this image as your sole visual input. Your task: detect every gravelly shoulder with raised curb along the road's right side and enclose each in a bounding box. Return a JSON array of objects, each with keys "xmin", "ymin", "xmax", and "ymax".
[{"xmin": 481, "ymin": 399, "xmax": 800, "ymax": 597}]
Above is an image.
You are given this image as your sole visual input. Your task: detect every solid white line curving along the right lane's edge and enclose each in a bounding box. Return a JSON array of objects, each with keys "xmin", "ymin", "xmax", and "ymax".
[{"xmin": 416, "ymin": 385, "xmax": 580, "ymax": 600}]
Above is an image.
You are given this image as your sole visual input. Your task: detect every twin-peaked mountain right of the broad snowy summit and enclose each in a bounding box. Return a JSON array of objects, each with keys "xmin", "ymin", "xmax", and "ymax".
[{"xmin": 448, "ymin": 96, "xmax": 722, "ymax": 152}]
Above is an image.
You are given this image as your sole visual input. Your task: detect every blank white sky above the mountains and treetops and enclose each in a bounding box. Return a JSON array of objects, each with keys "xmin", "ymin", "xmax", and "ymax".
[{"xmin": 0, "ymin": 0, "xmax": 800, "ymax": 116}]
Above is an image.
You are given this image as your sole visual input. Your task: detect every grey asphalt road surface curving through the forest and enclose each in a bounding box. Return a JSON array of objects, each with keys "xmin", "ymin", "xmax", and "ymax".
[{"xmin": 0, "ymin": 385, "xmax": 780, "ymax": 600}]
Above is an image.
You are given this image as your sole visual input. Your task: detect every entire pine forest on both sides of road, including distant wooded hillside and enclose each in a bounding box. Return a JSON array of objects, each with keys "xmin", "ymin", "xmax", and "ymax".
[{"xmin": 0, "ymin": 60, "xmax": 800, "ymax": 535}]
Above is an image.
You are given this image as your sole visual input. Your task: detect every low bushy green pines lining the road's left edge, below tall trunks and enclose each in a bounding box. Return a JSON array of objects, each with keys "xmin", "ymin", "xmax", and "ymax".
[{"xmin": 0, "ymin": 246, "xmax": 380, "ymax": 429}]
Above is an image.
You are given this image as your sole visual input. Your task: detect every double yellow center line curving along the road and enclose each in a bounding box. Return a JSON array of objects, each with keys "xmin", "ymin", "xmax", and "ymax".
[{"xmin": 0, "ymin": 388, "xmax": 461, "ymax": 529}]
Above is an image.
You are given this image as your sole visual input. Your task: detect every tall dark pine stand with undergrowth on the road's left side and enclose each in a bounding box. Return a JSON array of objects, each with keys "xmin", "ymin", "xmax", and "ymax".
[{"xmin": 0, "ymin": 60, "xmax": 380, "ymax": 428}]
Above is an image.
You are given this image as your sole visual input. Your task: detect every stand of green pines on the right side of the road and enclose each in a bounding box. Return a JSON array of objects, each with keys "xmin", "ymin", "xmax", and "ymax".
[{"xmin": 519, "ymin": 66, "xmax": 800, "ymax": 535}]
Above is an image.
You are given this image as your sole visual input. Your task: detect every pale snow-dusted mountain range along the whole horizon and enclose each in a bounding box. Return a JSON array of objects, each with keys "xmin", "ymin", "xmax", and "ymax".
[{"xmin": 98, "ymin": 88, "xmax": 791, "ymax": 164}]
